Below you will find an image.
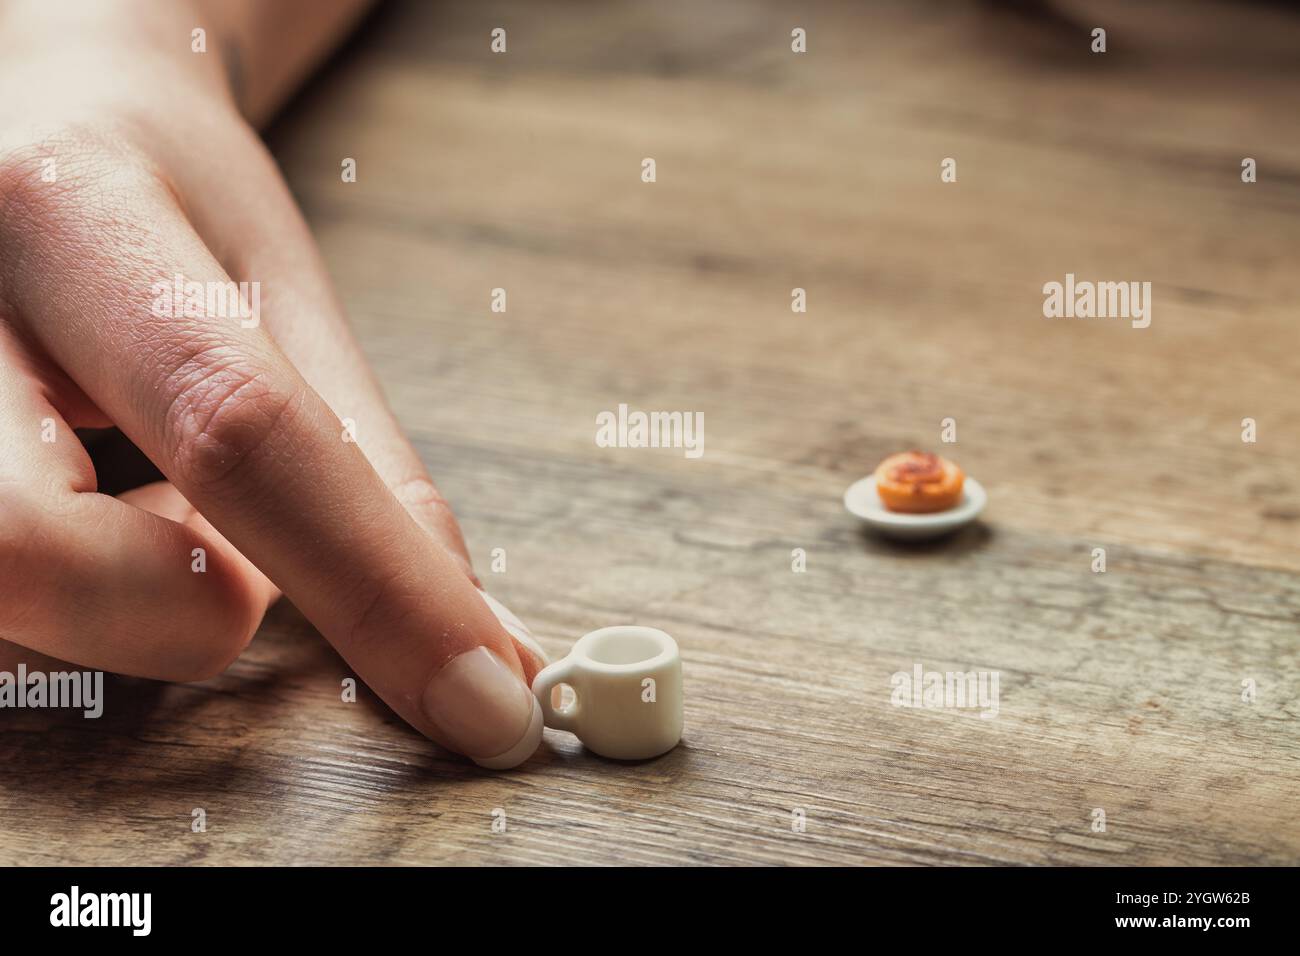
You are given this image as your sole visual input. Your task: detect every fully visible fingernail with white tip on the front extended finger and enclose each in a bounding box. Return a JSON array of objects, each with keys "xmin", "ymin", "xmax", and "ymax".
[{"xmin": 420, "ymin": 646, "xmax": 542, "ymax": 770}]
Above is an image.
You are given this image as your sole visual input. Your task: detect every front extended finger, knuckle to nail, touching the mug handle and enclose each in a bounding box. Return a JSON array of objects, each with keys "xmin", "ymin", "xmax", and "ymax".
[{"xmin": 0, "ymin": 155, "xmax": 542, "ymax": 766}]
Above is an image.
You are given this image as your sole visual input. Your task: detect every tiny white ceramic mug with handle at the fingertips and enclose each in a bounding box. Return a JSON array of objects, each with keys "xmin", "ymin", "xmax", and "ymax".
[{"xmin": 533, "ymin": 624, "xmax": 681, "ymax": 760}]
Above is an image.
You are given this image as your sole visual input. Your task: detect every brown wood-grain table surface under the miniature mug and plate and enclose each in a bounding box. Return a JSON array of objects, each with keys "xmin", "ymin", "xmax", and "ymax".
[{"xmin": 0, "ymin": 0, "xmax": 1300, "ymax": 865}]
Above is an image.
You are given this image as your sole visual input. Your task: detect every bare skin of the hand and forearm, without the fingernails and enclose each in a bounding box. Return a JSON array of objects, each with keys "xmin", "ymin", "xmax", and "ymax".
[{"xmin": 0, "ymin": 0, "xmax": 541, "ymax": 764}]
